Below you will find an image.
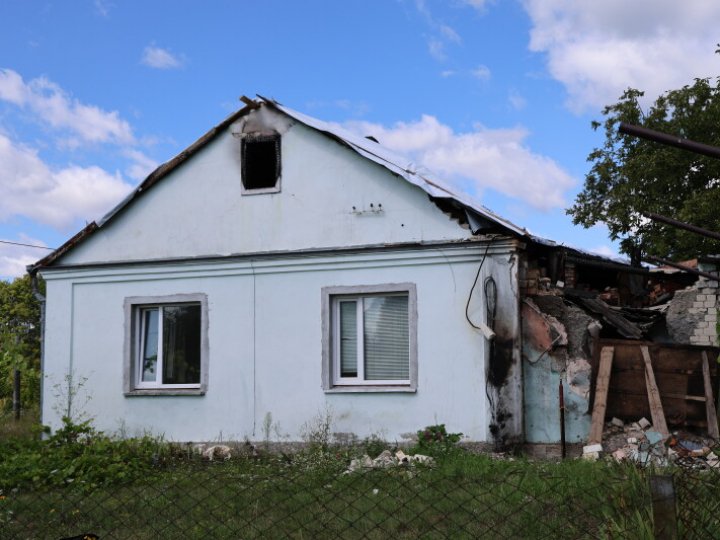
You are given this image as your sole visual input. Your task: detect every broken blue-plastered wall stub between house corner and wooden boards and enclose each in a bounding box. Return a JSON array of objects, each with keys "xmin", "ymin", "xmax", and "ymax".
[{"xmin": 521, "ymin": 295, "xmax": 599, "ymax": 443}]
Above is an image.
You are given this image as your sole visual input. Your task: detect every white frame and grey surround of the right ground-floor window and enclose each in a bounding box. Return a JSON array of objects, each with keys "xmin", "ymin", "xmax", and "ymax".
[{"xmin": 322, "ymin": 283, "xmax": 418, "ymax": 392}]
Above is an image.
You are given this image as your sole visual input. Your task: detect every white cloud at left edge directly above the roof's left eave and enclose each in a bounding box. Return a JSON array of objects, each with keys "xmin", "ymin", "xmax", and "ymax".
[{"xmin": 0, "ymin": 134, "xmax": 131, "ymax": 229}]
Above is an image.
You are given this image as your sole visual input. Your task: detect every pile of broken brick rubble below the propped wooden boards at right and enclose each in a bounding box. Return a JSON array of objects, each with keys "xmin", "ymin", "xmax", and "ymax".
[{"xmin": 583, "ymin": 418, "xmax": 720, "ymax": 468}]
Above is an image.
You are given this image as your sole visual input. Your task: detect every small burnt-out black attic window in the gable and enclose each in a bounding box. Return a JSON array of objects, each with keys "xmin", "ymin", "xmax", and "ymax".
[{"xmin": 241, "ymin": 133, "xmax": 280, "ymax": 193}]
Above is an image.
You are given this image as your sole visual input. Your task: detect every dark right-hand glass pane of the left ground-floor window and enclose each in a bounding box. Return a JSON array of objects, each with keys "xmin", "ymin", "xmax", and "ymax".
[{"xmin": 162, "ymin": 305, "xmax": 201, "ymax": 384}]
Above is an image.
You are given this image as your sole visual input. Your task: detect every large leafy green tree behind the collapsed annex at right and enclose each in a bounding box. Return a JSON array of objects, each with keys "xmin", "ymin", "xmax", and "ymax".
[{"xmin": 567, "ymin": 79, "xmax": 720, "ymax": 260}]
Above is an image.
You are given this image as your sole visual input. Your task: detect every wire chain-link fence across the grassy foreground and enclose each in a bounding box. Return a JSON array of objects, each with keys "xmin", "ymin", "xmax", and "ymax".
[{"xmin": 8, "ymin": 454, "xmax": 720, "ymax": 539}]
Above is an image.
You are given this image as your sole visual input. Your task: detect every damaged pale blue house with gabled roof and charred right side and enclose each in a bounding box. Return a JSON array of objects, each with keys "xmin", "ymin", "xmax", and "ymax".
[{"xmin": 29, "ymin": 98, "xmax": 715, "ymax": 447}]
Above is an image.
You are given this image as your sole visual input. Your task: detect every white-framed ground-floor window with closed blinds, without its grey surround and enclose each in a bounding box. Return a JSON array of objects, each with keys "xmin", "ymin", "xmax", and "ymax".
[{"xmin": 332, "ymin": 293, "xmax": 410, "ymax": 385}]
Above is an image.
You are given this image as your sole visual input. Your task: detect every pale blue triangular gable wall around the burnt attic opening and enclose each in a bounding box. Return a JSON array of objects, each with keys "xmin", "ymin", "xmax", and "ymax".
[{"xmin": 60, "ymin": 112, "xmax": 471, "ymax": 265}]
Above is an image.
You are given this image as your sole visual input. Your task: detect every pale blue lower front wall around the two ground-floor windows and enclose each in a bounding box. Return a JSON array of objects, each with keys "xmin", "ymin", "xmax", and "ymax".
[{"xmin": 43, "ymin": 243, "xmax": 522, "ymax": 441}]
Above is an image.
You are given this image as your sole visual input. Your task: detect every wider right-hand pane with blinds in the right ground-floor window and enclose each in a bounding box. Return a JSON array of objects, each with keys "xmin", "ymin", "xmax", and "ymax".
[{"xmin": 363, "ymin": 296, "xmax": 410, "ymax": 380}]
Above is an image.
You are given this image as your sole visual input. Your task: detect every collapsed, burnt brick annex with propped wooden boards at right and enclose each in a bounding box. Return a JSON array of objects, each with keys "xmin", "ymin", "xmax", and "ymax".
[{"xmin": 521, "ymin": 243, "xmax": 718, "ymax": 455}]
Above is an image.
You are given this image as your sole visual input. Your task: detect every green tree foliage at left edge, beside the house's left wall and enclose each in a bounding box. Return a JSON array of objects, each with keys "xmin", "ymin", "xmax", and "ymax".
[{"xmin": 0, "ymin": 276, "xmax": 45, "ymax": 407}]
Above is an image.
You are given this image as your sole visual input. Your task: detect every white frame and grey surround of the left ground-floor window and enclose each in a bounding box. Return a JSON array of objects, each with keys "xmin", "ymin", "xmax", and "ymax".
[{"xmin": 124, "ymin": 293, "xmax": 209, "ymax": 396}]
